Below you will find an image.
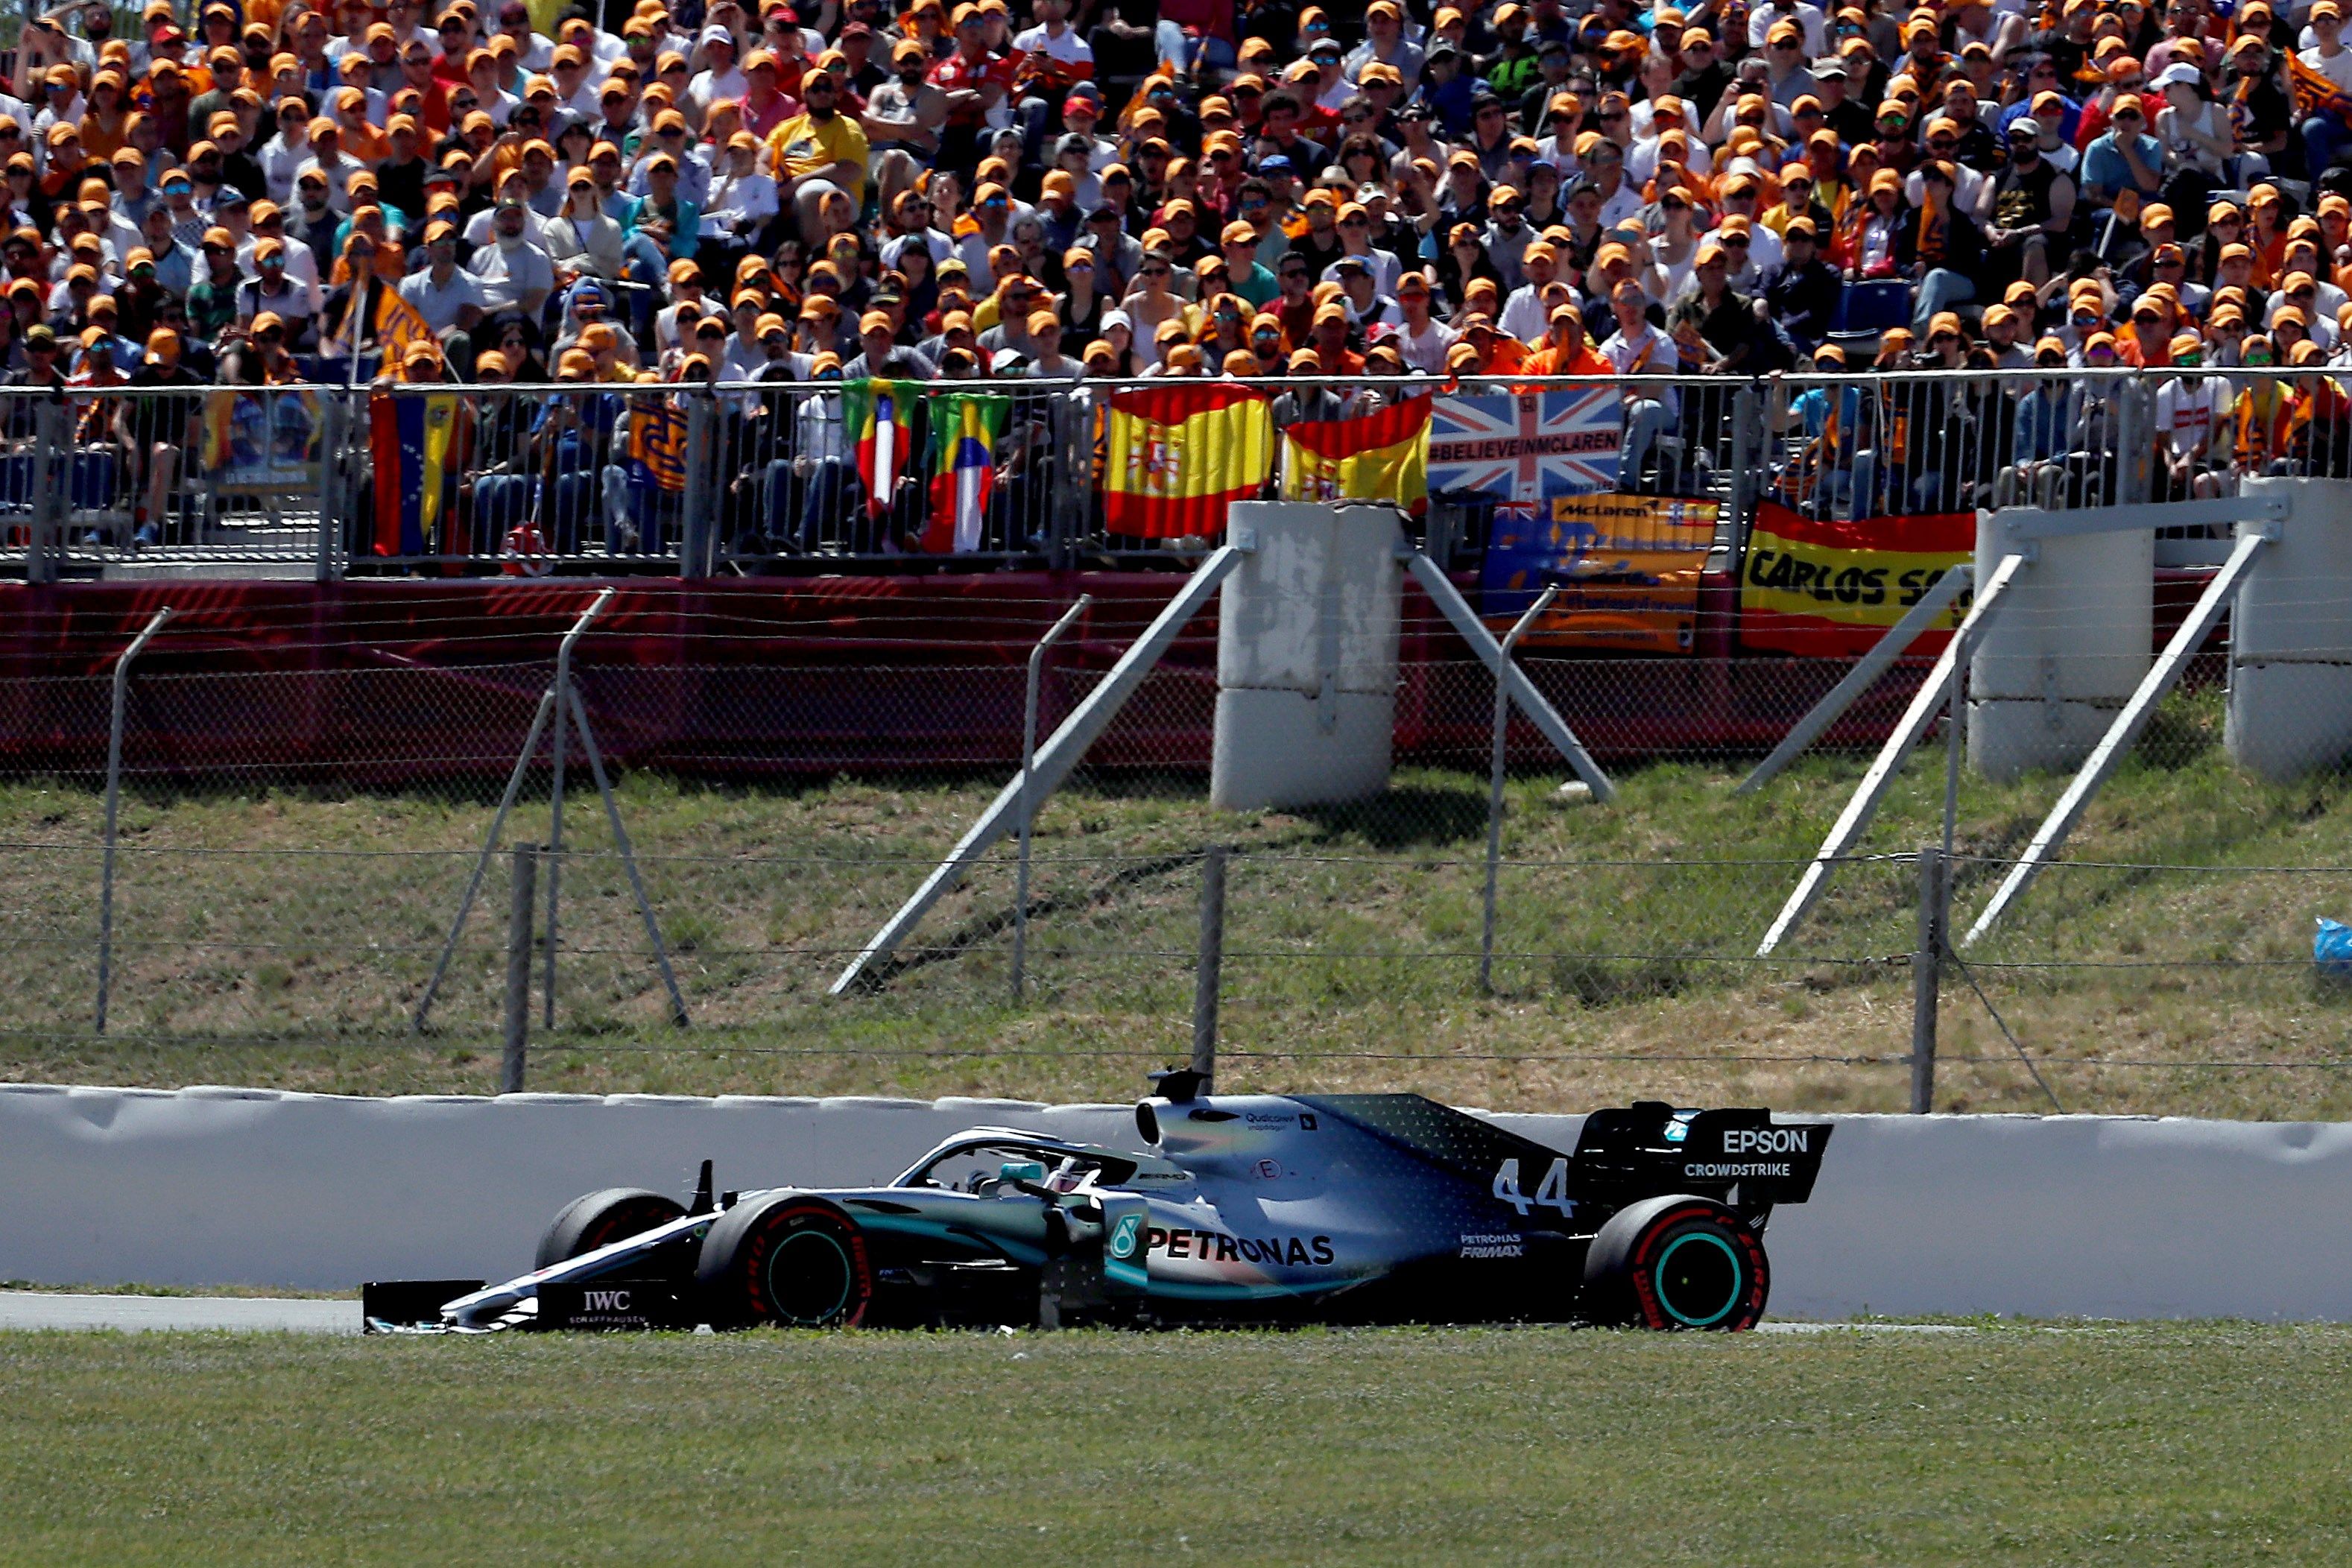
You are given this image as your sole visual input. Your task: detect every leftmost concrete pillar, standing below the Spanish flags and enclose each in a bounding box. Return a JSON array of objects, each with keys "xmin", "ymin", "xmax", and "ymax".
[{"xmin": 1209, "ymin": 501, "xmax": 1402, "ymax": 811}]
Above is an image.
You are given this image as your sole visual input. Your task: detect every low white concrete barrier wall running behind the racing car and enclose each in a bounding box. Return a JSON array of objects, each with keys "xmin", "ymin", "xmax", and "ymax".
[{"xmin": 0, "ymin": 1086, "xmax": 2352, "ymax": 1321}]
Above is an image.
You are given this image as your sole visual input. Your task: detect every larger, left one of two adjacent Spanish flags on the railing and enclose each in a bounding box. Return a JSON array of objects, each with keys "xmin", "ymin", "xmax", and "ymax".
[{"xmin": 1103, "ymin": 381, "xmax": 1275, "ymax": 538}]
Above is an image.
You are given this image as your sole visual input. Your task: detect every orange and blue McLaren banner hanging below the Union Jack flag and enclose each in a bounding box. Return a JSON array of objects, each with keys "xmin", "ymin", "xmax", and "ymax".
[{"xmin": 1479, "ymin": 496, "xmax": 1722, "ymax": 654}]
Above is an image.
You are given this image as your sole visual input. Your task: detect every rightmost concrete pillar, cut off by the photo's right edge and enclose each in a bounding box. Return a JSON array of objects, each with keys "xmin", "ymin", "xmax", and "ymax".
[{"xmin": 2225, "ymin": 480, "xmax": 2352, "ymax": 780}]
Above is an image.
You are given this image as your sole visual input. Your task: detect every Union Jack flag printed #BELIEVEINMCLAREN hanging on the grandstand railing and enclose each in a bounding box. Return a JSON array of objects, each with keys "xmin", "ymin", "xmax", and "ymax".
[{"xmin": 1430, "ymin": 385, "xmax": 1625, "ymax": 513}]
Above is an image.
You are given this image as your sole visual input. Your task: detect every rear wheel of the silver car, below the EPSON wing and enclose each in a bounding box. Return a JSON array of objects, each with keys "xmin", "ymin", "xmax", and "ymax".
[{"xmin": 1585, "ymin": 1194, "xmax": 1771, "ymax": 1333}]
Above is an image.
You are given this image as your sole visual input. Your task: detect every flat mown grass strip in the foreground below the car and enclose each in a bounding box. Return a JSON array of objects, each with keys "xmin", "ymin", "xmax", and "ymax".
[{"xmin": 0, "ymin": 1326, "xmax": 2352, "ymax": 1566}]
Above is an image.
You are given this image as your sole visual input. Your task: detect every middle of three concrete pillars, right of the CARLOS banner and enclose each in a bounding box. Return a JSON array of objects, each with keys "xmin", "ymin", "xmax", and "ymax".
[{"xmin": 1969, "ymin": 513, "xmax": 2157, "ymax": 783}]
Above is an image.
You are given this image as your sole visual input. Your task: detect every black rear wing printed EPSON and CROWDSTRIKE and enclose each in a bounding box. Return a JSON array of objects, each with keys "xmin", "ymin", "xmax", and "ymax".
[{"xmin": 1576, "ymin": 1100, "xmax": 1837, "ymax": 1208}]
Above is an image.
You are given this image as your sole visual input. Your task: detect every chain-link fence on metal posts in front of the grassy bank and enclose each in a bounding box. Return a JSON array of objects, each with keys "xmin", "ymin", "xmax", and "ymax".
[{"xmin": 0, "ymin": 604, "xmax": 2352, "ymax": 1114}]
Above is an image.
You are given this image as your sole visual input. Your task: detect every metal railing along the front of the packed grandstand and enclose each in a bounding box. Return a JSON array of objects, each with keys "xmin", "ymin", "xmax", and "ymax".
[{"xmin": 0, "ymin": 367, "xmax": 2352, "ymax": 581}]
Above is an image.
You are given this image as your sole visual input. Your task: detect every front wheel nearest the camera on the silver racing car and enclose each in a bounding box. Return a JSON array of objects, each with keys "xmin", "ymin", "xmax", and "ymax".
[{"xmin": 694, "ymin": 1192, "xmax": 875, "ymax": 1328}]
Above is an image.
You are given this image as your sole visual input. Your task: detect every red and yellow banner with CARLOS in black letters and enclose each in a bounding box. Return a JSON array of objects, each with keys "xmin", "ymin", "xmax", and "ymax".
[{"xmin": 1740, "ymin": 501, "xmax": 1976, "ymax": 658}]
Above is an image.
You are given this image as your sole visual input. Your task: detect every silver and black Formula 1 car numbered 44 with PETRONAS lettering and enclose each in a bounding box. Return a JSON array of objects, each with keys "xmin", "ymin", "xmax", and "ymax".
[{"xmin": 364, "ymin": 1072, "xmax": 1833, "ymax": 1333}]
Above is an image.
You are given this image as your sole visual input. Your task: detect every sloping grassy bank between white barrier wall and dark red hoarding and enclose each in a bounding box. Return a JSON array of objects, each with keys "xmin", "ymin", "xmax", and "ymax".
[{"xmin": 13, "ymin": 691, "xmax": 2352, "ymax": 1116}]
